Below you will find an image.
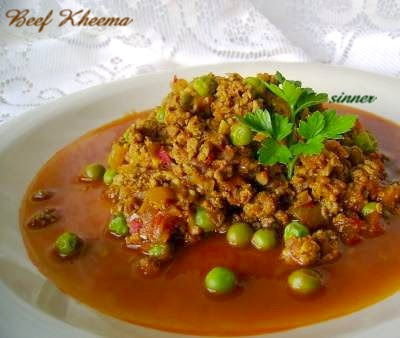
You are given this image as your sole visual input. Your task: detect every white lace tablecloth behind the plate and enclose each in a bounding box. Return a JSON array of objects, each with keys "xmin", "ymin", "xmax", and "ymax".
[{"xmin": 0, "ymin": 0, "xmax": 400, "ymax": 123}]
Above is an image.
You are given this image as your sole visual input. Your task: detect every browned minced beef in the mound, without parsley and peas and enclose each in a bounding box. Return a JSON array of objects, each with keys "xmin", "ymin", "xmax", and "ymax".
[{"xmin": 107, "ymin": 74, "xmax": 400, "ymax": 269}]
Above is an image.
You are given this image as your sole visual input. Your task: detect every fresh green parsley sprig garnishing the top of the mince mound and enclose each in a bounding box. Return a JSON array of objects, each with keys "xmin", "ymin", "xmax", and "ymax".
[{"xmin": 238, "ymin": 72, "xmax": 357, "ymax": 178}]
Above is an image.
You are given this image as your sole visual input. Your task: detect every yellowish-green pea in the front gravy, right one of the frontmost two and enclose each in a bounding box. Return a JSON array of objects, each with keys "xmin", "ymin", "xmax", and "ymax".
[{"xmin": 288, "ymin": 269, "xmax": 322, "ymax": 295}]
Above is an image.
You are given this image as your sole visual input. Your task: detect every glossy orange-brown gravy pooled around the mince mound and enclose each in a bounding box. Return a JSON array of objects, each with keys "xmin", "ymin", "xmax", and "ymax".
[{"xmin": 20, "ymin": 106, "xmax": 400, "ymax": 335}]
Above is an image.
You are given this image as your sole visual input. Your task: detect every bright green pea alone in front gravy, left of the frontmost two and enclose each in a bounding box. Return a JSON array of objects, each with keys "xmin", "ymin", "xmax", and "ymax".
[{"xmin": 204, "ymin": 266, "xmax": 237, "ymax": 294}]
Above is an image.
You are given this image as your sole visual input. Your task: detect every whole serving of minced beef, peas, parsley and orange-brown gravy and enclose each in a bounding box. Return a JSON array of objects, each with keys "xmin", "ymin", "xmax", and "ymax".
[{"xmin": 21, "ymin": 72, "xmax": 400, "ymax": 335}]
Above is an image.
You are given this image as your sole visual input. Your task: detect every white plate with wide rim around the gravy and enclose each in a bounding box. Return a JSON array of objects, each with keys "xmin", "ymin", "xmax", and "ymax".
[{"xmin": 0, "ymin": 63, "xmax": 400, "ymax": 338}]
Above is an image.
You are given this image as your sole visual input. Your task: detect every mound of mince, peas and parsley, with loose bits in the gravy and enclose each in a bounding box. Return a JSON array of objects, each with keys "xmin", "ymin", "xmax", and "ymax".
[{"xmin": 24, "ymin": 72, "xmax": 400, "ymax": 294}]
